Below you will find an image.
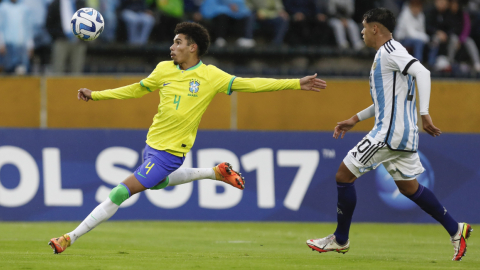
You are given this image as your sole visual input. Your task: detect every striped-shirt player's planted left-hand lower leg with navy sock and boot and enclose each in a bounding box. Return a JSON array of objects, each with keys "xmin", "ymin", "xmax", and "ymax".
[{"xmin": 307, "ymin": 162, "xmax": 357, "ymax": 254}]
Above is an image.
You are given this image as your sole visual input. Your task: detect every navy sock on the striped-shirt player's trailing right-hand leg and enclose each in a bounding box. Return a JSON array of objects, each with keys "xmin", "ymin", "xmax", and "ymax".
[{"xmin": 408, "ymin": 184, "xmax": 458, "ymax": 236}]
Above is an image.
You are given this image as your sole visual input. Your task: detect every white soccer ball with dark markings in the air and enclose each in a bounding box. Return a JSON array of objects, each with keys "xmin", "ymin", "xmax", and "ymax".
[{"xmin": 70, "ymin": 8, "xmax": 105, "ymax": 41}]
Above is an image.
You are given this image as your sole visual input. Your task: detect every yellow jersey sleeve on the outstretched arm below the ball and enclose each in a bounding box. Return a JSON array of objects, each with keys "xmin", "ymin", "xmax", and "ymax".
[{"xmin": 92, "ymin": 63, "xmax": 162, "ymax": 101}]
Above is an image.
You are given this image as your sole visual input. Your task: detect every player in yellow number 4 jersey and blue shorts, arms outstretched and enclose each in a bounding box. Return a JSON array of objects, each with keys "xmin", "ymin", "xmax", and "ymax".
[{"xmin": 49, "ymin": 22, "xmax": 327, "ymax": 253}]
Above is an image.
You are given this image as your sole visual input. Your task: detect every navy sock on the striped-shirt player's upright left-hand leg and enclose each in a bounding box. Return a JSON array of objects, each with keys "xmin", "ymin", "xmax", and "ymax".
[{"xmin": 334, "ymin": 182, "xmax": 357, "ymax": 245}]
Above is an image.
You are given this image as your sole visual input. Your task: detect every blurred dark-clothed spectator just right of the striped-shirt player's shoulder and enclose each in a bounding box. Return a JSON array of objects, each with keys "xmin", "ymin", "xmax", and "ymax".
[{"xmin": 425, "ymin": 0, "xmax": 451, "ymax": 70}]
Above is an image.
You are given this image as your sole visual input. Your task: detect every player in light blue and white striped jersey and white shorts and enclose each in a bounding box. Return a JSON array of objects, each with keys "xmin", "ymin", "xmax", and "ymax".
[{"xmin": 307, "ymin": 8, "xmax": 472, "ymax": 261}]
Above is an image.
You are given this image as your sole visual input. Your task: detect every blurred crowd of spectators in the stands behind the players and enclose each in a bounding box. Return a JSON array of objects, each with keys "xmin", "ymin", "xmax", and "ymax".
[{"xmin": 0, "ymin": 0, "xmax": 480, "ymax": 78}]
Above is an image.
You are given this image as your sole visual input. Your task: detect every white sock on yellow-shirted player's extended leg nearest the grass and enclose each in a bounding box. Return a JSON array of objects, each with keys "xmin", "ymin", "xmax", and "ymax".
[{"xmin": 67, "ymin": 198, "xmax": 119, "ymax": 244}]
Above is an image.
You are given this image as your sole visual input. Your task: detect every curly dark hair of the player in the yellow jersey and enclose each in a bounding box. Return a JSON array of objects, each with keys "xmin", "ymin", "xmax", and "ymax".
[{"xmin": 174, "ymin": 22, "xmax": 210, "ymax": 57}]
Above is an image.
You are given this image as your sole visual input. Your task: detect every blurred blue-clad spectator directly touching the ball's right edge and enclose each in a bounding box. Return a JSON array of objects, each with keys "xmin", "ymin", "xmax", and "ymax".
[{"xmin": 98, "ymin": 0, "xmax": 120, "ymax": 42}]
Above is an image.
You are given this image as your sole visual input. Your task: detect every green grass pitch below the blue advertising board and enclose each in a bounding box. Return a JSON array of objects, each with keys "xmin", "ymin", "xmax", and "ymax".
[{"xmin": 0, "ymin": 221, "xmax": 480, "ymax": 270}]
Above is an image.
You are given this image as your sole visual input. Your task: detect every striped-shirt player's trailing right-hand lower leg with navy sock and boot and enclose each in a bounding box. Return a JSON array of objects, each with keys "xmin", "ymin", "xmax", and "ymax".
[{"xmin": 395, "ymin": 179, "xmax": 473, "ymax": 261}]
